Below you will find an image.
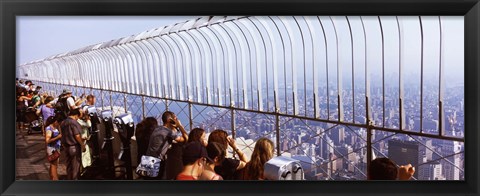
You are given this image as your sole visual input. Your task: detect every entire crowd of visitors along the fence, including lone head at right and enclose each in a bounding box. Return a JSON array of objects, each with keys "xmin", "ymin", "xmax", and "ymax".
[{"xmin": 16, "ymin": 80, "xmax": 415, "ymax": 180}]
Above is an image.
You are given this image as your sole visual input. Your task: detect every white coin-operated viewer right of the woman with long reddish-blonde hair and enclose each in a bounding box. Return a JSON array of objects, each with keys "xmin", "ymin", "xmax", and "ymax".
[{"xmin": 264, "ymin": 156, "xmax": 304, "ymax": 180}]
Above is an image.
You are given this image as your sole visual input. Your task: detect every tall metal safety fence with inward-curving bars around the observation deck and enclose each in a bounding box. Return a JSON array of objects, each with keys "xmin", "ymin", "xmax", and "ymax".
[{"xmin": 18, "ymin": 16, "xmax": 465, "ymax": 180}]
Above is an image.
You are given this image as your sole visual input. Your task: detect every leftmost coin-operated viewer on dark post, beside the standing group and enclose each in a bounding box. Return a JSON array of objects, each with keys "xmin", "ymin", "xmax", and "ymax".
[{"xmin": 100, "ymin": 110, "xmax": 115, "ymax": 178}]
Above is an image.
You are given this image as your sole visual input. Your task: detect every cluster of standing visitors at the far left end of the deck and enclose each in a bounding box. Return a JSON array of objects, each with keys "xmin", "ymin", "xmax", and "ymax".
[{"xmin": 16, "ymin": 79, "xmax": 95, "ymax": 180}]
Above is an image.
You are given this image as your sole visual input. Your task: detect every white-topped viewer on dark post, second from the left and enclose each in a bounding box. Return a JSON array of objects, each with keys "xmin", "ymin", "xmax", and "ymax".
[{"xmin": 113, "ymin": 113, "xmax": 135, "ymax": 180}]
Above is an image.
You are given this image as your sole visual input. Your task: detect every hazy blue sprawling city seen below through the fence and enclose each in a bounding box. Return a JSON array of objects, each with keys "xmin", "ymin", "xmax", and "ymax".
[{"xmin": 106, "ymin": 73, "xmax": 464, "ymax": 180}]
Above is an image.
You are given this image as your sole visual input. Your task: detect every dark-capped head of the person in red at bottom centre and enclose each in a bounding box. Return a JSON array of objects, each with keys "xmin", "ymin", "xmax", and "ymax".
[{"xmin": 182, "ymin": 142, "xmax": 208, "ymax": 168}]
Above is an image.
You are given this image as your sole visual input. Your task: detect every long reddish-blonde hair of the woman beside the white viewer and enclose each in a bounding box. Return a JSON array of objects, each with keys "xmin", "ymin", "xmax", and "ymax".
[{"xmin": 243, "ymin": 138, "xmax": 274, "ymax": 180}]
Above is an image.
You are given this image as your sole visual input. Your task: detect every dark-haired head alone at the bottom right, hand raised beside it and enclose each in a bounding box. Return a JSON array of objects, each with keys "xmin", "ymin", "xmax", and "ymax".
[{"xmin": 368, "ymin": 158, "xmax": 398, "ymax": 180}]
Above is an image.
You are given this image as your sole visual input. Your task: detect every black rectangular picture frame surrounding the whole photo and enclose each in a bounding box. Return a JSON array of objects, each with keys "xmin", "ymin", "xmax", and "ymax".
[{"xmin": 0, "ymin": 0, "xmax": 480, "ymax": 195}]
